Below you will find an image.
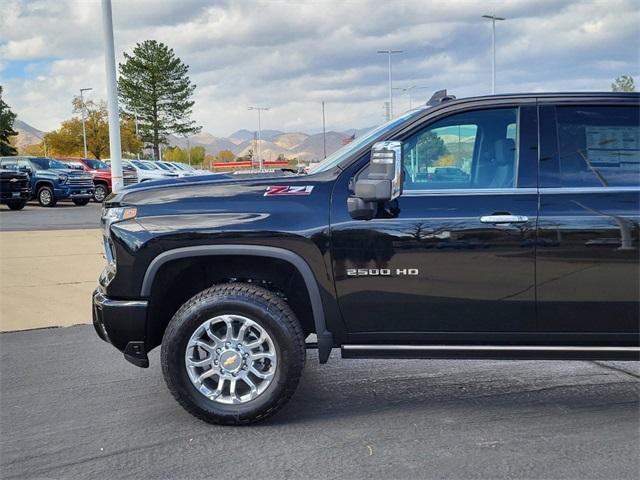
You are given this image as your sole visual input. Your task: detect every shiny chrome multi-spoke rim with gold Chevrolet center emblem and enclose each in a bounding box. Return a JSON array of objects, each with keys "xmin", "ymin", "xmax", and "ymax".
[{"xmin": 185, "ymin": 315, "xmax": 278, "ymax": 405}]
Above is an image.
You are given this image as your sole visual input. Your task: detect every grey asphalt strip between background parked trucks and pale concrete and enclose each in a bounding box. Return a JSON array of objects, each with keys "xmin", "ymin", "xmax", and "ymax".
[{"xmin": 0, "ymin": 201, "xmax": 102, "ymax": 232}]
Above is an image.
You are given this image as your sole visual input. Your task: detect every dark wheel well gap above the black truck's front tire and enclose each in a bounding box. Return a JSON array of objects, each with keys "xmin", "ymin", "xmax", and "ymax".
[{"xmin": 146, "ymin": 255, "xmax": 315, "ymax": 351}]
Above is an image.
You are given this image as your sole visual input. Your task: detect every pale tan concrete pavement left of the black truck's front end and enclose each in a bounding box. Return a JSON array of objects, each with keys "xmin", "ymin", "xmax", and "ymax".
[{"xmin": 0, "ymin": 229, "xmax": 105, "ymax": 332}]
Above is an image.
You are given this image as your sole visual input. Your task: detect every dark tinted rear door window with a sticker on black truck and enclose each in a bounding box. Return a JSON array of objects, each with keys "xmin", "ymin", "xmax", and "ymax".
[{"xmin": 541, "ymin": 106, "xmax": 640, "ymax": 187}]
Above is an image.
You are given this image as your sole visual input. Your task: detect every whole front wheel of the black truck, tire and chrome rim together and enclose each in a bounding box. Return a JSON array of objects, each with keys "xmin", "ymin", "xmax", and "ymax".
[{"xmin": 161, "ymin": 283, "xmax": 305, "ymax": 425}]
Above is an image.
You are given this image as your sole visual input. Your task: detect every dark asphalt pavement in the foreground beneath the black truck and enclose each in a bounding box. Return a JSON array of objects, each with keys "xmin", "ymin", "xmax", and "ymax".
[{"xmin": 0, "ymin": 326, "xmax": 640, "ymax": 479}]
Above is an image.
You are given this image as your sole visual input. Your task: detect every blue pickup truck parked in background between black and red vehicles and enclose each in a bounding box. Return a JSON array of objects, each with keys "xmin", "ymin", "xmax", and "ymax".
[{"xmin": 0, "ymin": 157, "xmax": 94, "ymax": 207}]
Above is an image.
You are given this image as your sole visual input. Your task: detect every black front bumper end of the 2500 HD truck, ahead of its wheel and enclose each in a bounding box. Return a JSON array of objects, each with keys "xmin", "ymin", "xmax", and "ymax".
[{"xmin": 93, "ymin": 289, "xmax": 149, "ymax": 368}]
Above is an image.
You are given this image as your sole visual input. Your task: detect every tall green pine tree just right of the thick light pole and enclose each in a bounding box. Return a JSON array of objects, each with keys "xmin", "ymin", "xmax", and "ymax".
[{"xmin": 118, "ymin": 40, "xmax": 202, "ymax": 159}]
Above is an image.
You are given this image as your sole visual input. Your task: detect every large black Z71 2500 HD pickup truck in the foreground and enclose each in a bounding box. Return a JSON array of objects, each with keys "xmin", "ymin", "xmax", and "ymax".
[{"xmin": 93, "ymin": 91, "xmax": 640, "ymax": 424}]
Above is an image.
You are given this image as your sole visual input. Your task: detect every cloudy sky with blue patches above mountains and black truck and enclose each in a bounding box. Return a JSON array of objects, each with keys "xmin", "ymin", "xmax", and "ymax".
[{"xmin": 0, "ymin": 0, "xmax": 640, "ymax": 136}]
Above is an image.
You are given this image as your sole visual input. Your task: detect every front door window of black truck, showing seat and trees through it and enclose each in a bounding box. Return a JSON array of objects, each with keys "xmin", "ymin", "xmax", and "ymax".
[{"xmin": 403, "ymin": 108, "xmax": 518, "ymax": 191}]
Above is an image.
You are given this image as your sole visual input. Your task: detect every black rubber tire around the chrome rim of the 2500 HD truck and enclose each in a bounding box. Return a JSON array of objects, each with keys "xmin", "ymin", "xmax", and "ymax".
[{"xmin": 161, "ymin": 283, "xmax": 306, "ymax": 425}]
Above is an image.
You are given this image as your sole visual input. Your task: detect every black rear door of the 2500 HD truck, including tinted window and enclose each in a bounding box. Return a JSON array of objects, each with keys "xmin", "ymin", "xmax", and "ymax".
[{"xmin": 536, "ymin": 100, "xmax": 640, "ymax": 344}]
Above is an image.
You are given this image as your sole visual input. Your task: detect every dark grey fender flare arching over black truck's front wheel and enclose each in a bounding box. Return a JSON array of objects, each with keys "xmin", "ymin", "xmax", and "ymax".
[{"xmin": 140, "ymin": 245, "xmax": 333, "ymax": 363}]
